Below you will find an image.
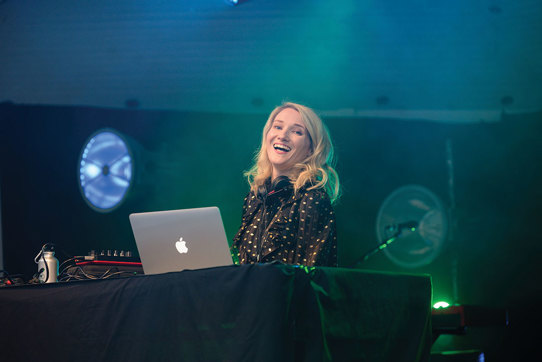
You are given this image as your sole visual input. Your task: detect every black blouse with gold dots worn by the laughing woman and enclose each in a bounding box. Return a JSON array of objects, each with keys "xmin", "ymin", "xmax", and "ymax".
[{"xmin": 232, "ymin": 184, "xmax": 337, "ymax": 266}]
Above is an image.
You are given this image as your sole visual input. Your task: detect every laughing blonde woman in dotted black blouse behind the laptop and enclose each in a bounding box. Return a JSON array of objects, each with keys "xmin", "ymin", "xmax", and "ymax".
[{"xmin": 232, "ymin": 103, "xmax": 339, "ymax": 266}]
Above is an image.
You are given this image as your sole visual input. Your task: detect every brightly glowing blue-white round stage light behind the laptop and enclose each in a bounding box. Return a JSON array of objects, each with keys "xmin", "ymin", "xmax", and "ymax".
[{"xmin": 78, "ymin": 129, "xmax": 134, "ymax": 212}]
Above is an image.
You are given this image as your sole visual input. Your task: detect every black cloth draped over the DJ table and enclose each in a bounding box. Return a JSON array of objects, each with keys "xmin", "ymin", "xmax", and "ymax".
[{"xmin": 0, "ymin": 264, "xmax": 431, "ymax": 362}]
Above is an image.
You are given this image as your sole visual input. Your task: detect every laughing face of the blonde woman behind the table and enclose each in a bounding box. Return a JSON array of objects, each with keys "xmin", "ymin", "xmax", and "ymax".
[{"xmin": 265, "ymin": 108, "xmax": 311, "ymax": 179}]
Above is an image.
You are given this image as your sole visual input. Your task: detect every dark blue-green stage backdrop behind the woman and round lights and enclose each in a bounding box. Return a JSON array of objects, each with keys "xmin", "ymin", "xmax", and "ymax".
[{"xmin": 0, "ymin": 104, "xmax": 542, "ymax": 358}]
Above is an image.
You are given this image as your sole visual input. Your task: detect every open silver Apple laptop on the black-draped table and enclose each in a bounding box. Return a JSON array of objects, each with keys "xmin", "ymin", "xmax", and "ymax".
[{"xmin": 130, "ymin": 207, "xmax": 233, "ymax": 274}]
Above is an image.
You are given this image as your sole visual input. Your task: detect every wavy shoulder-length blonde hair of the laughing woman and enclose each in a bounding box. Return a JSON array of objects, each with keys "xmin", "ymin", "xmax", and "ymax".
[{"xmin": 245, "ymin": 102, "xmax": 340, "ymax": 203}]
